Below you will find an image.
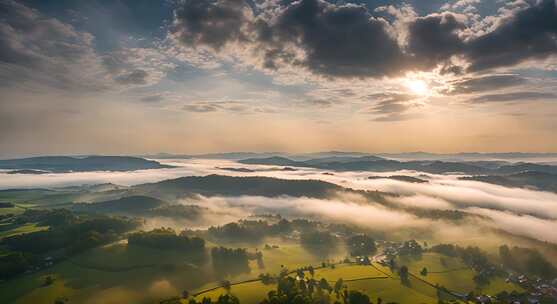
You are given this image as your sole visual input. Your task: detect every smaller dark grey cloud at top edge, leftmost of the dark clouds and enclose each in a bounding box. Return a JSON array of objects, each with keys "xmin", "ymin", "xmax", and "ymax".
[{"xmin": 174, "ymin": 0, "xmax": 250, "ymax": 50}]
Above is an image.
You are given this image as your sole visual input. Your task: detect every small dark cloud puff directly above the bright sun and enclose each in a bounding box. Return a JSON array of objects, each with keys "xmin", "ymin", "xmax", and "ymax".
[{"xmin": 408, "ymin": 13, "xmax": 465, "ymax": 69}]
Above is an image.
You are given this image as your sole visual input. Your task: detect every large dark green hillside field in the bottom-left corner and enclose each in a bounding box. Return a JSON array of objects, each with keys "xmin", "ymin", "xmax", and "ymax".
[{"xmin": 0, "ymin": 244, "xmax": 211, "ymax": 304}]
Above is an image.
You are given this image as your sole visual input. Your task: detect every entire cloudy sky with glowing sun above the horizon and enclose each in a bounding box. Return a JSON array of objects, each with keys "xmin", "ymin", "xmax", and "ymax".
[{"xmin": 0, "ymin": 0, "xmax": 557, "ymax": 157}]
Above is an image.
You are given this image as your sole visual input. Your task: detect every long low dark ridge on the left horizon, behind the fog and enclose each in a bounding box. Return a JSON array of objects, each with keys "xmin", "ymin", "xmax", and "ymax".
[{"xmin": 0, "ymin": 156, "xmax": 172, "ymax": 173}]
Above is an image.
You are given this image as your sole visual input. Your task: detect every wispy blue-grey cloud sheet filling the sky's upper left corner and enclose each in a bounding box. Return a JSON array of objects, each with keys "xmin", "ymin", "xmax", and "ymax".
[{"xmin": 0, "ymin": 0, "xmax": 175, "ymax": 93}]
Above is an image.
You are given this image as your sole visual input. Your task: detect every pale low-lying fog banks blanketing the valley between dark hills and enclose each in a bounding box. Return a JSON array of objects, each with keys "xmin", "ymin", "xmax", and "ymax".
[{"xmin": 0, "ymin": 159, "xmax": 557, "ymax": 244}]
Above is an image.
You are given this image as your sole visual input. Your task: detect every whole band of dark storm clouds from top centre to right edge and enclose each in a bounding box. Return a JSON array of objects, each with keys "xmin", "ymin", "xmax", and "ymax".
[{"xmin": 174, "ymin": 0, "xmax": 557, "ymax": 82}]
